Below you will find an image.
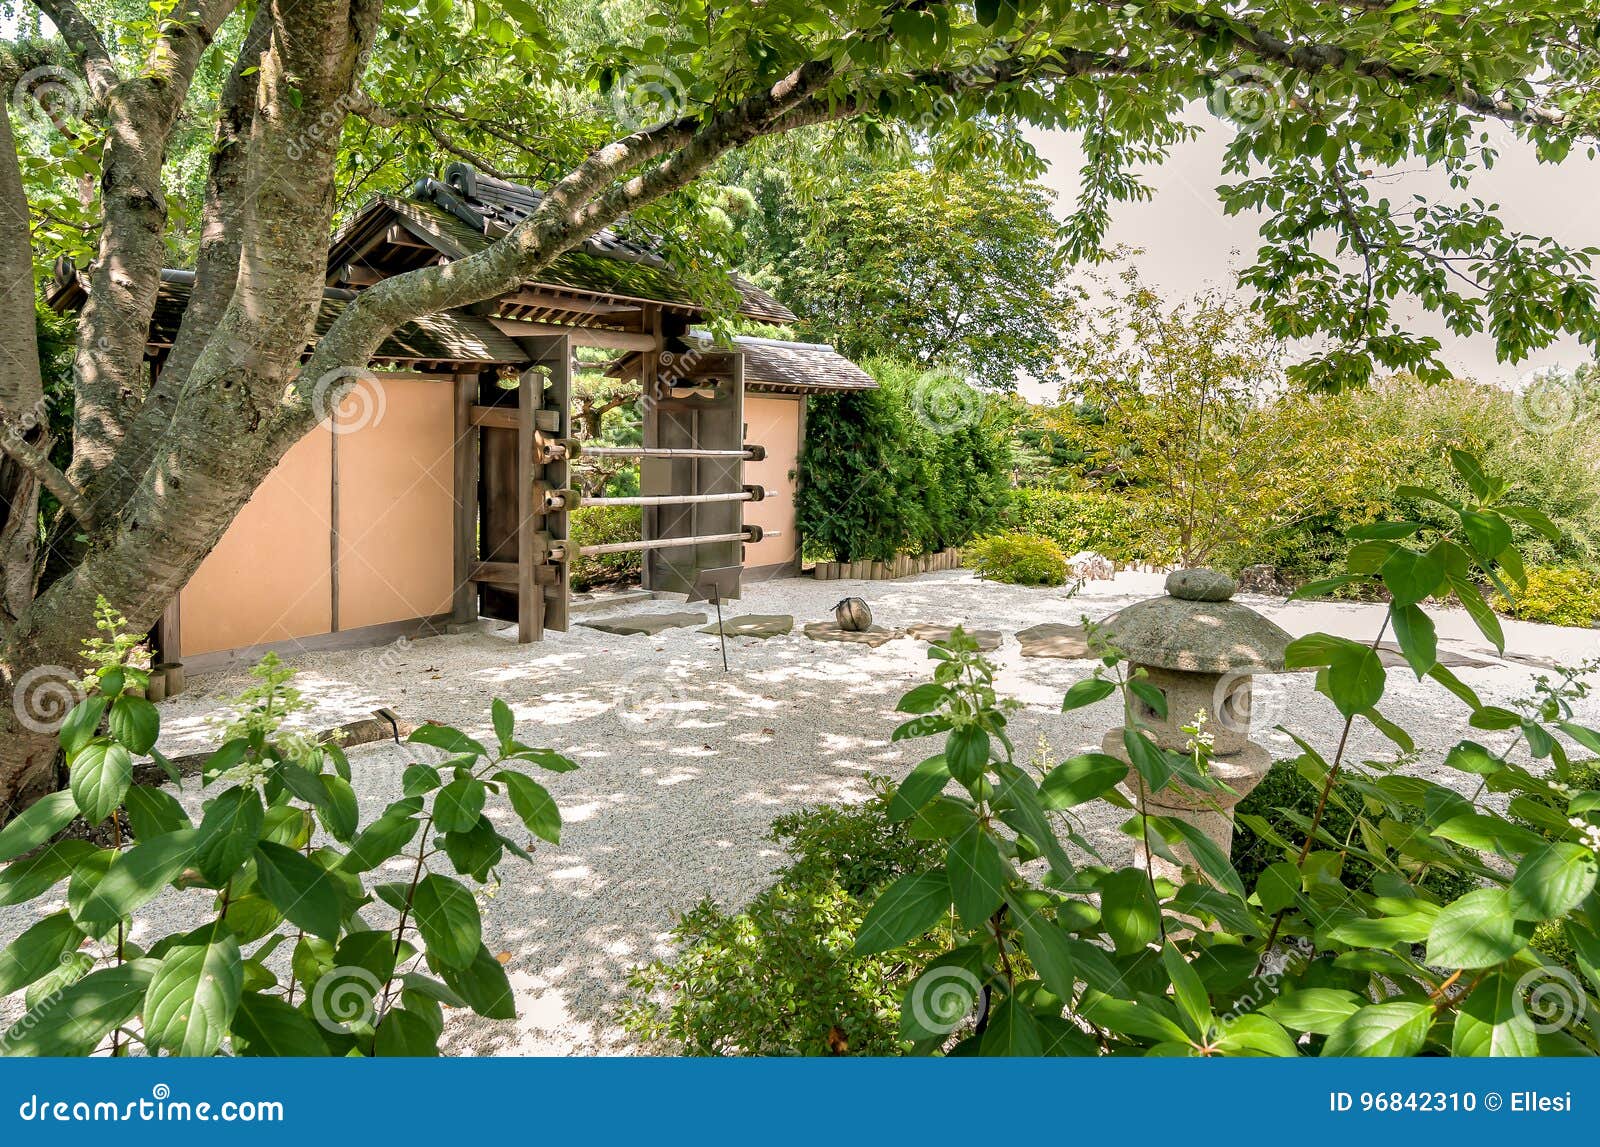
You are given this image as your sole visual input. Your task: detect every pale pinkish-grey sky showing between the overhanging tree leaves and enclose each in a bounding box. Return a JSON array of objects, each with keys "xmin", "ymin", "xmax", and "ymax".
[{"xmin": 1021, "ymin": 116, "xmax": 1600, "ymax": 398}]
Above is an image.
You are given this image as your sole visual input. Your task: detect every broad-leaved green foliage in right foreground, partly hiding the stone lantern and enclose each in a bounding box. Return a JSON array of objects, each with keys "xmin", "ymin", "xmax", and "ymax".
[{"xmin": 858, "ymin": 453, "xmax": 1600, "ymax": 1056}]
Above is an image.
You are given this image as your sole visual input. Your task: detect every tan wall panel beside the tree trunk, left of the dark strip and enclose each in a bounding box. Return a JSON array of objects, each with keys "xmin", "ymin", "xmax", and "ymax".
[{"xmin": 179, "ymin": 426, "xmax": 333, "ymax": 656}]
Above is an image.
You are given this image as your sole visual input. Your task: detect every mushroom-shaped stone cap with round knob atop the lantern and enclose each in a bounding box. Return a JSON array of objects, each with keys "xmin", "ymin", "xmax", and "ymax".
[{"xmin": 1106, "ymin": 570, "xmax": 1293, "ymax": 673}]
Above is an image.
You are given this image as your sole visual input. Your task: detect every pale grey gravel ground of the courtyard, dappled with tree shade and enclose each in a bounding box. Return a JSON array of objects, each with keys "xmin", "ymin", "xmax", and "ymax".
[{"xmin": 0, "ymin": 571, "xmax": 1600, "ymax": 1054}]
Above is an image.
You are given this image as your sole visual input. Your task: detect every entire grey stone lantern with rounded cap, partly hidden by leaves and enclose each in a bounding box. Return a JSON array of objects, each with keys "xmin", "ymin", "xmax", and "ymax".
[{"xmin": 1104, "ymin": 570, "xmax": 1291, "ymax": 878}]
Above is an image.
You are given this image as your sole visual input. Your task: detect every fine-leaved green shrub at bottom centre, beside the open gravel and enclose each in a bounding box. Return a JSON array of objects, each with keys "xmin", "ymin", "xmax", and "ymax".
[{"xmin": 622, "ymin": 781, "xmax": 939, "ymax": 1056}]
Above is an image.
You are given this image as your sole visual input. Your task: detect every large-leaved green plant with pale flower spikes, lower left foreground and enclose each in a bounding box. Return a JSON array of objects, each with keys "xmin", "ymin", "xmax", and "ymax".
[{"xmin": 0, "ymin": 598, "xmax": 576, "ymax": 1056}]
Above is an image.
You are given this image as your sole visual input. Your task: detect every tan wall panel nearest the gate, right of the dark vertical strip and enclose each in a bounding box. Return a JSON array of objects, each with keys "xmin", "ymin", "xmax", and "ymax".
[{"xmin": 338, "ymin": 381, "xmax": 454, "ymax": 629}]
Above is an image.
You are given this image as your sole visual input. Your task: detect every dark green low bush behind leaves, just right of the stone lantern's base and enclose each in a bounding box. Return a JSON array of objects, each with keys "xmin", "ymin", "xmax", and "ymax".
[{"xmin": 1234, "ymin": 760, "xmax": 1478, "ymax": 904}]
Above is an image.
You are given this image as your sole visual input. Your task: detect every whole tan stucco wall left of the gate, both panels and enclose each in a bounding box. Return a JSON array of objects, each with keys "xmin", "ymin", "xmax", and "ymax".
[{"xmin": 179, "ymin": 379, "xmax": 454, "ymax": 657}]
